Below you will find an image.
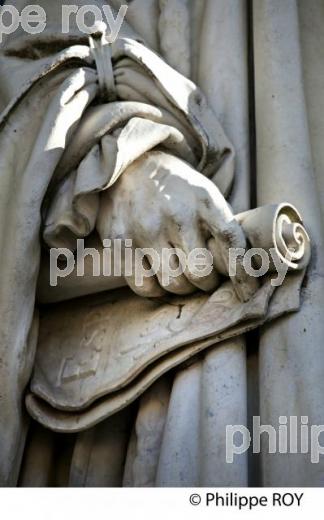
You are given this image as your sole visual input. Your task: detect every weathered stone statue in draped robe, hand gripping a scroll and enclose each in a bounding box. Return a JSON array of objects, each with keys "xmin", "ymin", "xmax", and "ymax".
[{"xmin": 0, "ymin": 0, "xmax": 320, "ymax": 486}]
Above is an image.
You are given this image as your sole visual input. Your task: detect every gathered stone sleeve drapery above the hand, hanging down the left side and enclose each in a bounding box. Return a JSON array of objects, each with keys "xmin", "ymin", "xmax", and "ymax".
[{"xmin": 0, "ymin": 28, "xmax": 234, "ymax": 484}]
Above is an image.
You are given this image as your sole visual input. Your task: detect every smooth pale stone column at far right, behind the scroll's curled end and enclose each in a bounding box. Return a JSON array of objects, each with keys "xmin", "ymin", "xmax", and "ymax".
[{"xmin": 254, "ymin": 0, "xmax": 324, "ymax": 486}]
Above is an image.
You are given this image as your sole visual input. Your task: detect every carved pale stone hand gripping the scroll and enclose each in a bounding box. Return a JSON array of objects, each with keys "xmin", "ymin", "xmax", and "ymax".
[{"xmin": 97, "ymin": 151, "xmax": 255, "ymax": 300}]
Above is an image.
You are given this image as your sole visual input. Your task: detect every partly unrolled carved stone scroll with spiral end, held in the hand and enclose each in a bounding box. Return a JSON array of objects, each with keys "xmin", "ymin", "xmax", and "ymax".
[{"xmin": 26, "ymin": 204, "xmax": 310, "ymax": 432}]
